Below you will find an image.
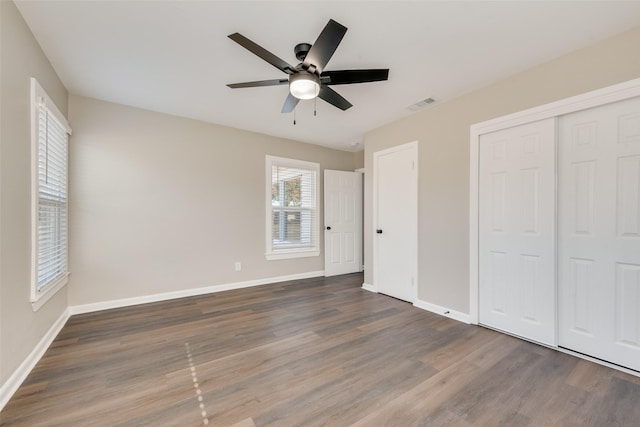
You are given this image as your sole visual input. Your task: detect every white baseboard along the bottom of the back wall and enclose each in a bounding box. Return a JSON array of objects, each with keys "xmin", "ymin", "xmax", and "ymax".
[{"xmin": 69, "ymin": 270, "xmax": 324, "ymax": 315}]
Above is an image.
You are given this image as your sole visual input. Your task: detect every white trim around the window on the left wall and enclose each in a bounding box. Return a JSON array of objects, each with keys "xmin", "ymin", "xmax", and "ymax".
[{"xmin": 30, "ymin": 77, "xmax": 71, "ymax": 311}]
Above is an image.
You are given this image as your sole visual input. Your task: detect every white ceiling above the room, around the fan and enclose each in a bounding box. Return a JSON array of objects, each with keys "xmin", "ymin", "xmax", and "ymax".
[{"xmin": 16, "ymin": 0, "xmax": 640, "ymax": 151}]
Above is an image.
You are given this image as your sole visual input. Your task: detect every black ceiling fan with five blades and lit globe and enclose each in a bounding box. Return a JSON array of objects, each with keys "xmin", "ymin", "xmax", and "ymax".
[{"xmin": 227, "ymin": 19, "xmax": 389, "ymax": 113}]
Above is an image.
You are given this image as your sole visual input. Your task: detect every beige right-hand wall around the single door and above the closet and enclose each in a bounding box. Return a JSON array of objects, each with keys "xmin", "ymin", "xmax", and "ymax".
[{"xmin": 365, "ymin": 28, "xmax": 640, "ymax": 313}]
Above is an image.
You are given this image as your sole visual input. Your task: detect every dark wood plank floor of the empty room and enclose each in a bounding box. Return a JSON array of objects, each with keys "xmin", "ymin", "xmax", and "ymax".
[{"xmin": 0, "ymin": 274, "xmax": 640, "ymax": 427}]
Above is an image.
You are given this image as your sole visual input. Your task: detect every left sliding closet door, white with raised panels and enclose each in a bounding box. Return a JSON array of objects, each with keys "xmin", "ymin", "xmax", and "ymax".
[{"xmin": 478, "ymin": 119, "xmax": 556, "ymax": 345}]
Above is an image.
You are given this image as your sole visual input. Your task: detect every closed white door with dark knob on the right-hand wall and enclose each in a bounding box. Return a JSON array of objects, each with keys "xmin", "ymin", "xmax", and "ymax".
[{"xmin": 368, "ymin": 143, "xmax": 418, "ymax": 302}]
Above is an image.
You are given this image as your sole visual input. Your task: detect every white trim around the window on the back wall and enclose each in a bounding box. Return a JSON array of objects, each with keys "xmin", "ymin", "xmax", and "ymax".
[{"xmin": 265, "ymin": 155, "xmax": 320, "ymax": 260}]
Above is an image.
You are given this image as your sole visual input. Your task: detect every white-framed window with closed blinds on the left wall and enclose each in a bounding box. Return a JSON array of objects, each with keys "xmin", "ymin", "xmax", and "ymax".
[{"xmin": 31, "ymin": 79, "xmax": 71, "ymax": 309}]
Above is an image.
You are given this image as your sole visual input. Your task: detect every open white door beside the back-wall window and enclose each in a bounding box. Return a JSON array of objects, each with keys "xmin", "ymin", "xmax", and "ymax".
[{"xmin": 324, "ymin": 169, "xmax": 362, "ymax": 276}]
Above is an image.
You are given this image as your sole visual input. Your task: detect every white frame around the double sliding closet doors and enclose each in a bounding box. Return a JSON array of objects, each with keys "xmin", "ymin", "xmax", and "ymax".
[{"xmin": 469, "ymin": 78, "xmax": 640, "ymax": 338}]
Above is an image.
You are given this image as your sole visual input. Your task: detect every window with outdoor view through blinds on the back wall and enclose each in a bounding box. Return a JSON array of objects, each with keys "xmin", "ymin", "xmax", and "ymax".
[{"xmin": 266, "ymin": 156, "xmax": 320, "ymax": 259}]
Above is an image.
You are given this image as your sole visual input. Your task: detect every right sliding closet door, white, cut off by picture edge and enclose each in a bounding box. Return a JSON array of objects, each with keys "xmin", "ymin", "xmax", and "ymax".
[{"xmin": 558, "ymin": 98, "xmax": 640, "ymax": 370}]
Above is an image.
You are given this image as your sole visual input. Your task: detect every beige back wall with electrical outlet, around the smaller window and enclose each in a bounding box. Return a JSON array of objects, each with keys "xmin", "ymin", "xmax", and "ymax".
[{"xmin": 69, "ymin": 96, "xmax": 356, "ymax": 305}]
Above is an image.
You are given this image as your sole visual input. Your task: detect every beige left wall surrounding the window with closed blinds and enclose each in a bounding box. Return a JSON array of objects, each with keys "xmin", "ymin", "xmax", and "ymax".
[{"xmin": 0, "ymin": 1, "xmax": 67, "ymax": 386}]
